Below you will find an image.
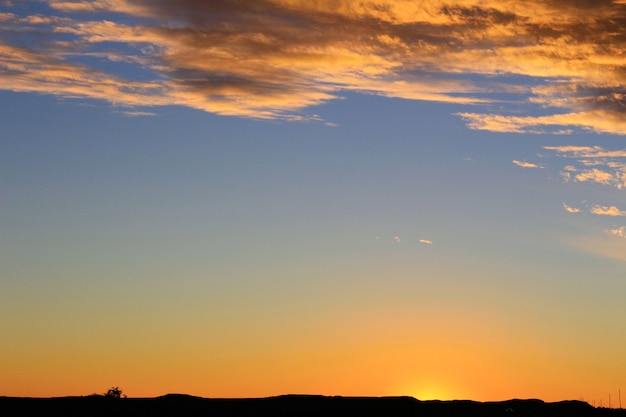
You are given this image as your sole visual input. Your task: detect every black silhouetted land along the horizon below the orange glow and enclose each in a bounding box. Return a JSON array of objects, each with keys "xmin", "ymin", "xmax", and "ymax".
[{"xmin": 0, "ymin": 394, "xmax": 626, "ymax": 417}]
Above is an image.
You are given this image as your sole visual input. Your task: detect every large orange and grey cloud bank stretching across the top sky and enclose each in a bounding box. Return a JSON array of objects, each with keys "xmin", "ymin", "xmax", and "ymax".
[{"xmin": 0, "ymin": 0, "xmax": 626, "ymax": 130}]
